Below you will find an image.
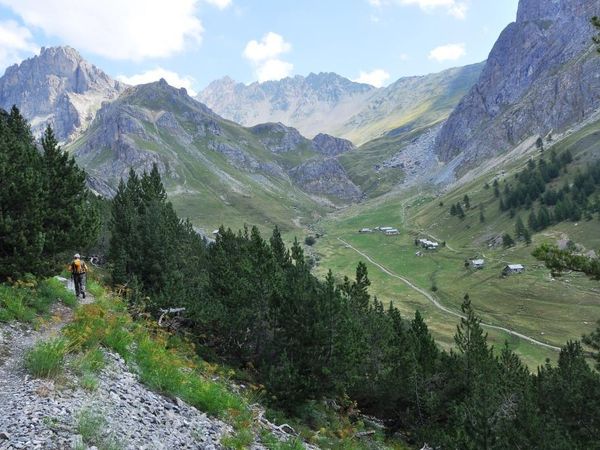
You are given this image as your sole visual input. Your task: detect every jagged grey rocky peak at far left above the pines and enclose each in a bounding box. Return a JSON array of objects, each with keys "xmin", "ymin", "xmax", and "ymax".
[{"xmin": 0, "ymin": 47, "xmax": 125, "ymax": 141}]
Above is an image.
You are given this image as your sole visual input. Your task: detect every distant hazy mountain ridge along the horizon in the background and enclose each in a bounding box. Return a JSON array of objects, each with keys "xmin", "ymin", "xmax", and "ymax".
[{"xmin": 197, "ymin": 64, "xmax": 483, "ymax": 145}]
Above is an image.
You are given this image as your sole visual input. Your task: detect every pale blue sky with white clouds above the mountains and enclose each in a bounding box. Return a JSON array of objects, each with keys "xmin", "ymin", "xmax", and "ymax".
[{"xmin": 0, "ymin": 0, "xmax": 518, "ymax": 95}]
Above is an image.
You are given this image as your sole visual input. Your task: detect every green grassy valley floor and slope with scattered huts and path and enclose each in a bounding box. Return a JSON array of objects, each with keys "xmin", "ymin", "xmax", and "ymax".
[{"xmin": 314, "ymin": 122, "xmax": 600, "ymax": 370}]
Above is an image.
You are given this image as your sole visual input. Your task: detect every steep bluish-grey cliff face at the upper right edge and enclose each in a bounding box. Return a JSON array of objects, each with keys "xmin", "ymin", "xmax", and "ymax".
[{"xmin": 435, "ymin": 0, "xmax": 600, "ymax": 170}]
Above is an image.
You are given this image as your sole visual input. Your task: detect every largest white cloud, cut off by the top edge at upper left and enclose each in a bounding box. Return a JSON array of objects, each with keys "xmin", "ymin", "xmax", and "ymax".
[{"xmin": 0, "ymin": 0, "xmax": 203, "ymax": 61}]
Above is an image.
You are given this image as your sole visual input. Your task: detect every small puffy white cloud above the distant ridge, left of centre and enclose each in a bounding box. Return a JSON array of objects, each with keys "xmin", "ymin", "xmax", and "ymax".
[{"xmin": 243, "ymin": 32, "xmax": 294, "ymax": 83}]
